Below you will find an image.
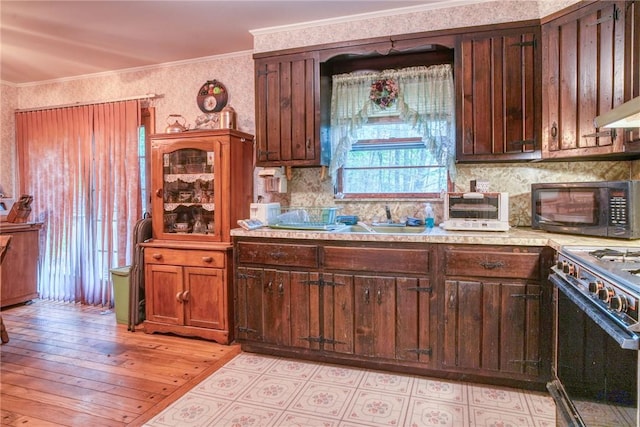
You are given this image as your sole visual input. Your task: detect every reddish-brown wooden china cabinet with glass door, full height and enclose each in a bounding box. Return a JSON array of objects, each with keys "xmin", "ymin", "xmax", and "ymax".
[{"xmin": 142, "ymin": 129, "xmax": 254, "ymax": 344}]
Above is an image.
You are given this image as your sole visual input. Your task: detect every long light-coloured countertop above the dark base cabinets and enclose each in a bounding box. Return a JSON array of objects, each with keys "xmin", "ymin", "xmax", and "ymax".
[{"xmin": 231, "ymin": 227, "xmax": 640, "ymax": 250}]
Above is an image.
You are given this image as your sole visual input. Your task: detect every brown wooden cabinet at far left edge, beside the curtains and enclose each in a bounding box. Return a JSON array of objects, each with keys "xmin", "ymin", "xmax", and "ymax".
[{"xmin": 0, "ymin": 222, "xmax": 42, "ymax": 307}]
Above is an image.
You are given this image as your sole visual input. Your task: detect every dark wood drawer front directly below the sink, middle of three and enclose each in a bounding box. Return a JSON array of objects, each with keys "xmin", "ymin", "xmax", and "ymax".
[{"xmin": 324, "ymin": 246, "xmax": 429, "ymax": 274}]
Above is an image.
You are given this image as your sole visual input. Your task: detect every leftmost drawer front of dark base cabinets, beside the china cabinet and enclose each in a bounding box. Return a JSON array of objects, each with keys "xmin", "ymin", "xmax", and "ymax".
[{"xmin": 237, "ymin": 242, "xmax": 318, "ymax": 268}]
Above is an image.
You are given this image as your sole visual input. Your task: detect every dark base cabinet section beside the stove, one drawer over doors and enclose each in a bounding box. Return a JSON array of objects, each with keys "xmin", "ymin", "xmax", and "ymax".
[{"xmin": 441, "ymin": 246, "xmax": 552, "ymax": 383}]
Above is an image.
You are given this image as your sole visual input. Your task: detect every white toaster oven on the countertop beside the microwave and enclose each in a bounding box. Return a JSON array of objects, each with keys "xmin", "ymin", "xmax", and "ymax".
[{"xmin": 440, "ymin": 193, "xmax": 509, "ymax": 231}]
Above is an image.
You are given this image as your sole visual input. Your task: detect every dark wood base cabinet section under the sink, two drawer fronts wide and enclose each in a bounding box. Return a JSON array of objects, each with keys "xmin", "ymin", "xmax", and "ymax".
[{"xmin": 235, "ymin": 239, "xmax": 437, "ymax": 368}]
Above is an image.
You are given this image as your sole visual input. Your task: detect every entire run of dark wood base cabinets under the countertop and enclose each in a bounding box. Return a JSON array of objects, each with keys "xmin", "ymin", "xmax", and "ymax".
[{"xmin": 234, "ymin": 237, "xmax": 552, "ymax": 390}]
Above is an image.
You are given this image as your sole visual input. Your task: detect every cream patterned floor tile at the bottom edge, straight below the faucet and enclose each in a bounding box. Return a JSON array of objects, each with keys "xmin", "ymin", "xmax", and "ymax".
[{"xmin": 344, "ymin": 390, "xmax": 409, "ymax": 426}]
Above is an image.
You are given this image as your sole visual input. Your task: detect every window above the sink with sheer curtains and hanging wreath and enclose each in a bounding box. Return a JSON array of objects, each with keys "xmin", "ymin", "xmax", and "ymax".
[{"xmin": 329, "ymin": 64, "xmax": 455, "ymax": 198}]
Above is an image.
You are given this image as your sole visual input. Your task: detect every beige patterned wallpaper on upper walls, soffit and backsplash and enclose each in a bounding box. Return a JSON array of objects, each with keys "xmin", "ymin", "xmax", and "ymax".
[{"xmin": 0, "ymin": 0, "xmax": 640, "ymax": 229}]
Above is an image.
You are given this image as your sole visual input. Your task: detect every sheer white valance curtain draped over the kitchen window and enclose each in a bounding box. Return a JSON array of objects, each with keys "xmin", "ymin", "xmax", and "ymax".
[{"xmin": 329, "ymin": 64, "xmax": 456, "ymax": 185}]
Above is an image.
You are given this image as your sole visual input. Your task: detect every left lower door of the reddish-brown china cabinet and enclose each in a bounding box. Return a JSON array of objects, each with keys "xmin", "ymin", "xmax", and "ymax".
[{"xmin": 145, "ymin": 264, "xmax": 185, "ymax": 325}]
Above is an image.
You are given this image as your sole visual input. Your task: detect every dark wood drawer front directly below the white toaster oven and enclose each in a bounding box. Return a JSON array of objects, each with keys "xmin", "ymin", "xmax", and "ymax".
[{"xmin": 444, "ymin": 249, "xmax": 540, "ymax": 280}]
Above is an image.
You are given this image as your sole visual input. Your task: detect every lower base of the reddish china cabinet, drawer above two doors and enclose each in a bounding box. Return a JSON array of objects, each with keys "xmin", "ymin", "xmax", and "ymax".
[{"xmin": 144, "ymin": 243, "xmax": 233, "ymax": 344}]
